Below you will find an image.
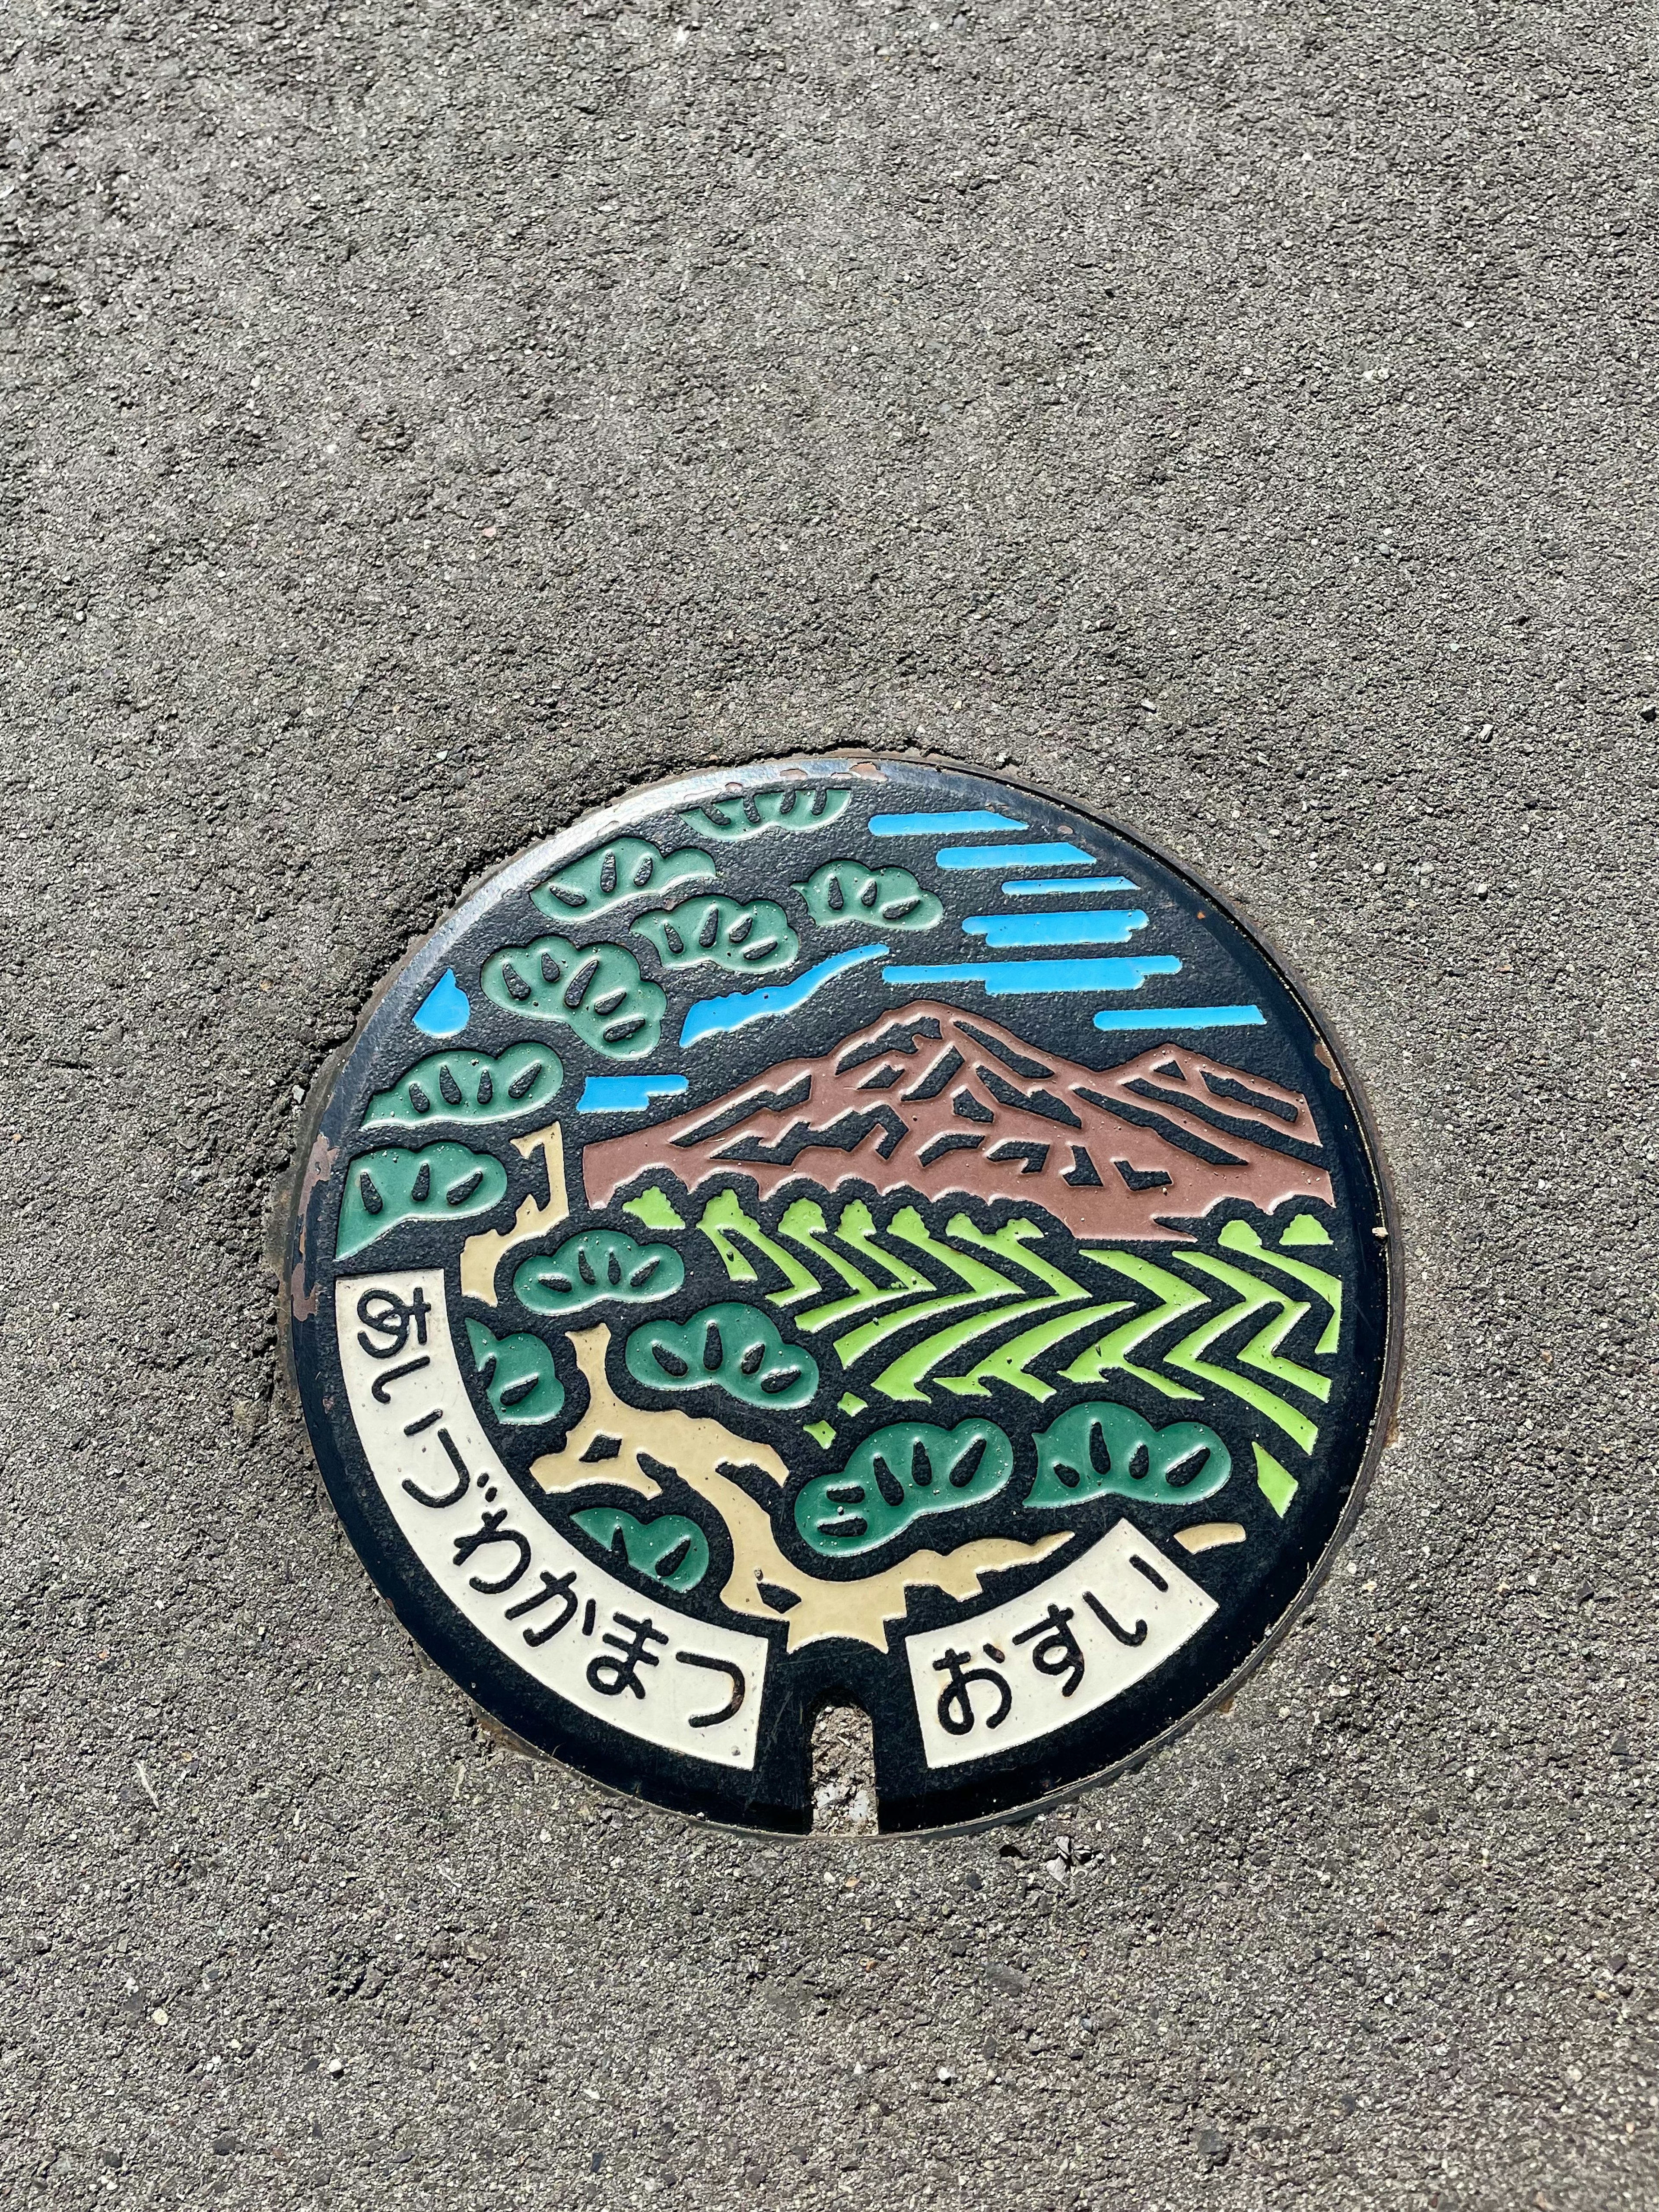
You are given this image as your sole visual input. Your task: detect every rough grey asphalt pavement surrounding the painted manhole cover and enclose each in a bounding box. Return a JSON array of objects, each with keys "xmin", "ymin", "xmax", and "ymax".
[{"xmin": 0, "ymin": 0, "xmax": 1659, "ymax": 2212}]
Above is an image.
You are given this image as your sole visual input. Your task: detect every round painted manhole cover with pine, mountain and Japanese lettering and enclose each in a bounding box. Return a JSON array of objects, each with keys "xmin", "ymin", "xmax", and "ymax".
[{"xmin": 290, "ymin": 759, "xmax": 1391, "ymax": 1829}]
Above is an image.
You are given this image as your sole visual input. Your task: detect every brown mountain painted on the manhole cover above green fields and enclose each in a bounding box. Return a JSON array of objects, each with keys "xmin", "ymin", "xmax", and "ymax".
[{"xmin": 582, "ymin": 1000, "xmax": 1332, "ymax": 1239}]
